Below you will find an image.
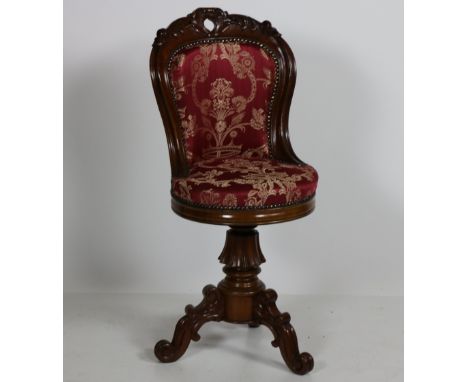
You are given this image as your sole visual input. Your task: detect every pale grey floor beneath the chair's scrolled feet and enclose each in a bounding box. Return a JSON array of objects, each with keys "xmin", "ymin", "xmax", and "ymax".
[{"xmin": 64, "ymin": 294, "xmax": 403, "ymax": 382}]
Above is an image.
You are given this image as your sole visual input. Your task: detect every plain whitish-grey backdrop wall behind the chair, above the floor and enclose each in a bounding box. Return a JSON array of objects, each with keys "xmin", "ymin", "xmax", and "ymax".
[{"xmin": 64, "ymin": 0, "xmax": 403, "ymax": 295}]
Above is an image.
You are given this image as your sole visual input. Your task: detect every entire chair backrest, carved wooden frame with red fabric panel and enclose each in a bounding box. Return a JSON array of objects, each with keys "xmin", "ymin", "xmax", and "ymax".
[{"xmin": 150, "ymin": 8, "xmax": 302, "ymax": 177}]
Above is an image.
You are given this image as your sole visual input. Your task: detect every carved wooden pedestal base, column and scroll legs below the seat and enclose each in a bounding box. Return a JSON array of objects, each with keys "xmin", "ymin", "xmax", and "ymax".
[{"xmin": 154, "ymin": 226, "xmax": 314, "ymax": 374}]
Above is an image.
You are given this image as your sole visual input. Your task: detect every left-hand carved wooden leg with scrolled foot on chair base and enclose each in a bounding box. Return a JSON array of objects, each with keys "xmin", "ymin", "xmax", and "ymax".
[{"xmin": 154, "ymin": 285, "xmax": 224, "ymax": 362}]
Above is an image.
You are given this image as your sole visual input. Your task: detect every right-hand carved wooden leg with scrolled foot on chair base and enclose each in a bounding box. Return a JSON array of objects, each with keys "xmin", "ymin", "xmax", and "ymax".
[{"xmin": 254, "ymin": 289, "xmax": 314, "ymax": 375}]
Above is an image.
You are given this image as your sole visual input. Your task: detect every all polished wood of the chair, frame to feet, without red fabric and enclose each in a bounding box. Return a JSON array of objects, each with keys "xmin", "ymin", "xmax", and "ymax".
[{"xmin": 150, "ymin": 8, "xmax": 315, "ymax": 374}]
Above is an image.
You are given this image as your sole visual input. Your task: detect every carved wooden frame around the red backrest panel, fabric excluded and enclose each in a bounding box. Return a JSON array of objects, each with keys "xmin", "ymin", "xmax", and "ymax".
[{"xmin": 150, "ymin": 8, "xmax": 304, "ymax": 177}]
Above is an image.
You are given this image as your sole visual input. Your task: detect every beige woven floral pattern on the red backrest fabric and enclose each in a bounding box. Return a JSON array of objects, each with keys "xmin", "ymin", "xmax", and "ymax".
[{"xmin": 173, "ymin": 43, "xmax": 271, "ymax": 159}]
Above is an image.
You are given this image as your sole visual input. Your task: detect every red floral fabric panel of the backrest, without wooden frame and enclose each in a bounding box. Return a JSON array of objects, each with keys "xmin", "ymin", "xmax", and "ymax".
[{"xmin": 170, "ymin": 42, "xmax": 276, "ymax": 164}]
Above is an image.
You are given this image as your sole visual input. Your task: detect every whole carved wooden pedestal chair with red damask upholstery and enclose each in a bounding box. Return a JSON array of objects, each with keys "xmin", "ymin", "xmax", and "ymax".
[{"xmin": 150, "ymin": 8, "xmax": 318, "ymax": 374}]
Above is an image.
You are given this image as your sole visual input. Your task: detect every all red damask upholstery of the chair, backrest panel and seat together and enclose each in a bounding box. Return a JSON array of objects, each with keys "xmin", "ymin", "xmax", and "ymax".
[{"xmin": 170, "ymin": 42, "xmax": 318, "ymax": 208}]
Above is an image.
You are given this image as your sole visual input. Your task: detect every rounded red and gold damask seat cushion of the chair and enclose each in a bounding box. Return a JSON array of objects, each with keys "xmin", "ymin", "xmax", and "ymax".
[{"xmin": 172, "ymin": 157, "xmax": 318, "ymax": 209}]
